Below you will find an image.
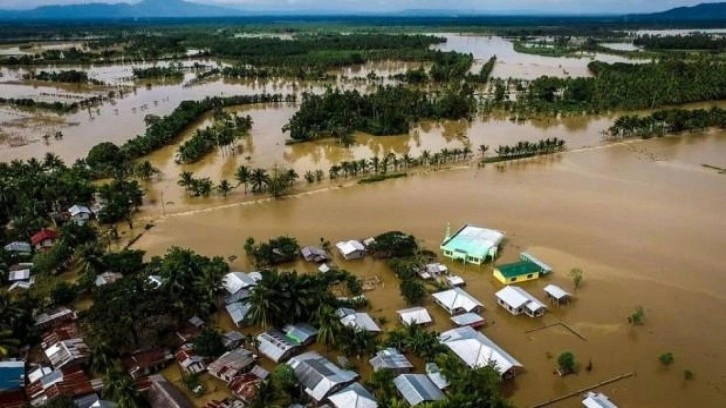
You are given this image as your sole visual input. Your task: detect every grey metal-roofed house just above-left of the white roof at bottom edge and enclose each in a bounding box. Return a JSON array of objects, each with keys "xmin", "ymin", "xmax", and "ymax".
[{"xmin": 287, "ymin": 351, "xmax": 358, "ymax": 402}]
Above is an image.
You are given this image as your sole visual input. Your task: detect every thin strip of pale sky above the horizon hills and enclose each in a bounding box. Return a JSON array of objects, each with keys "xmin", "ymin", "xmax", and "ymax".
[{"xmin": 0, "ymin": 0, "xmax": 726, "ymax": 14}]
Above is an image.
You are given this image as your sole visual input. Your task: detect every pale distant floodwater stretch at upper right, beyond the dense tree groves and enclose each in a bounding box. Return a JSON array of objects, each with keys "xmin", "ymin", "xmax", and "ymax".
[{"xmin": 435, "ymin": 34, "xmax": 635, "ymax": 79}]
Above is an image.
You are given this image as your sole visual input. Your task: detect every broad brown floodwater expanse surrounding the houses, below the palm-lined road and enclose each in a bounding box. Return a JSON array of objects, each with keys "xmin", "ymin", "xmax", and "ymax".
[{"xmin": 135, "ymin": 131, "xmax": 726, "ymax": 407}]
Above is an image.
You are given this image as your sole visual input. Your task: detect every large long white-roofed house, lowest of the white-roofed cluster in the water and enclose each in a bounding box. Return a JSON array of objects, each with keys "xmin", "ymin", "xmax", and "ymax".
[{"xmin": 439, "ymin": 326, "xmax": 522, "ymax": 378}]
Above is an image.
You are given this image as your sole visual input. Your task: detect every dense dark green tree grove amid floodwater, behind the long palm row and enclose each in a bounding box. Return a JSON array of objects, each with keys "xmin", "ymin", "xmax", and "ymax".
[{"xmin": 283, "ymin": 86, "xmax": 474, "ymax": 141}]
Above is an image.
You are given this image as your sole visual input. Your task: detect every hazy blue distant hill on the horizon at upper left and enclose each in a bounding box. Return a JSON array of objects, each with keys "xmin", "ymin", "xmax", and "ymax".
[{"xmin": 0, "ymin": 0, "xmax": 243, "ymax": 20}]
